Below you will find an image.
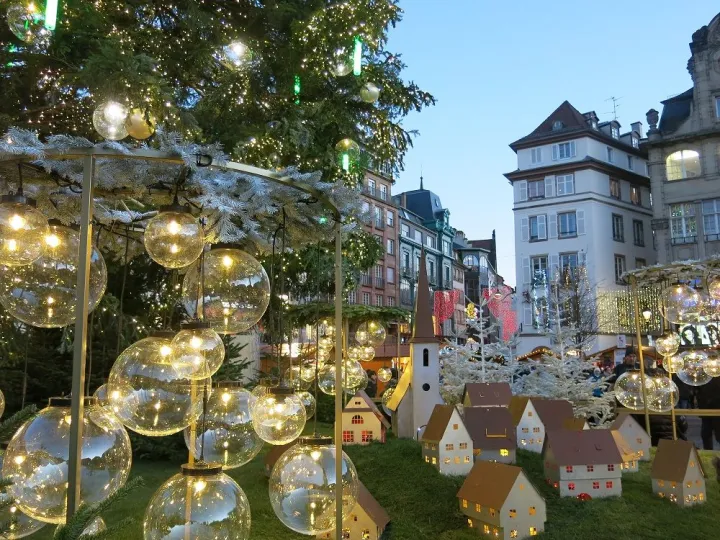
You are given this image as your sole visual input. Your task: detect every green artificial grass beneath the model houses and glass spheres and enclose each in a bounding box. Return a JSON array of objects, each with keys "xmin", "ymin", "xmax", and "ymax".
[{"xmin": 30, "ymin": 426, "xmax": 720, "ymax": 540}]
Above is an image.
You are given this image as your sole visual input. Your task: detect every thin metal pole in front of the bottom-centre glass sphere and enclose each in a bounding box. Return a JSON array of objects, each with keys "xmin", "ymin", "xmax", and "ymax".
[{"xmin": 335, "ymin": 220, "xmax": 343, "ymax": 540}]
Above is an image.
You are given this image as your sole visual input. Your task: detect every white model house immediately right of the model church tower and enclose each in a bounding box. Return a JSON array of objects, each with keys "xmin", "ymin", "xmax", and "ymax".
[{"xmin": 420, "ymin": 405, "xmax": 473, "ymax": 476}]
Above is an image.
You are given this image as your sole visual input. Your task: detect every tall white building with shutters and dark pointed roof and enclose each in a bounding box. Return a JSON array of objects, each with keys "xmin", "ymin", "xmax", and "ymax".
[{"xmin": 505, "ymin": 101, "xmax": 656, "ymax": 355}]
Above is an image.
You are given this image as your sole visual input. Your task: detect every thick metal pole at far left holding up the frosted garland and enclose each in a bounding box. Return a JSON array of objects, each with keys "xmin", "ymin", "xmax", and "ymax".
[{"xmin": 66, "ymin": 154, "xmax": 95, "ymax": 521}]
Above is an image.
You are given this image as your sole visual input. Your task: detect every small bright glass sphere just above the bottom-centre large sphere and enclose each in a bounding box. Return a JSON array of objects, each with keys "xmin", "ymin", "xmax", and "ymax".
[{"xmin": 251, "ymin": 387, "xmax": 307, "ymax": 445}]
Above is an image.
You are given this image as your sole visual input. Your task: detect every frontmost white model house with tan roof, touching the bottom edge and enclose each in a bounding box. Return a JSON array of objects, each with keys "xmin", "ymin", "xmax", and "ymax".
[{"xmin": 457, "ymin": 461, "xmax": 547, "ymax": 540}]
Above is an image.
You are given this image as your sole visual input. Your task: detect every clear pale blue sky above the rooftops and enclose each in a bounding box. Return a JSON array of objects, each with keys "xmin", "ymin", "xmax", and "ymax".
[{"xmin": 387, "ymin": 0, "xmax": 720, "ymax": 285}]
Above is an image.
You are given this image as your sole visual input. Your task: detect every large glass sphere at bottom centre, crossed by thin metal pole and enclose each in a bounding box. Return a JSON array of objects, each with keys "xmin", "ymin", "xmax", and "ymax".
[{"xmin": 268, "ymin": 437, "xmax": 359, "ymax": 536}]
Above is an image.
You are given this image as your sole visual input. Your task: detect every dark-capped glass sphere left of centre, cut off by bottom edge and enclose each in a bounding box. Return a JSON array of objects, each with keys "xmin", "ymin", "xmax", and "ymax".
[{"xmin": 143, "ymin": 463, "xmax": 251, "ymax": 540}]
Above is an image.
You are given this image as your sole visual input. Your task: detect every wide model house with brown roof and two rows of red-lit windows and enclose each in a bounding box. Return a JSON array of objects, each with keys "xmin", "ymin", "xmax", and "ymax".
[{"xmin": 543, "ymin": 429, "xmax": 622, "ymax": 499}]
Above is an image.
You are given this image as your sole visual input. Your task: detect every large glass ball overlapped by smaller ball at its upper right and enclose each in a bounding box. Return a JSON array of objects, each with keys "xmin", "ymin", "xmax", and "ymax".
[{"xmin": 107, "ymin": 337, "xmax": 212, "ymax": 437}]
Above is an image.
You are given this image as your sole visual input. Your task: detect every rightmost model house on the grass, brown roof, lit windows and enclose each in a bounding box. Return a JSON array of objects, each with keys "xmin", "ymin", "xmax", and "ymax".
[{"xmin": 650, "ymin": 439, "xmax": 707, "ymax": 506}]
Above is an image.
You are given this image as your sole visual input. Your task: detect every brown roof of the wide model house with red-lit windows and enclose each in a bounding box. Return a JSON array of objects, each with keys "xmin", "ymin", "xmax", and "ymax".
[{"xmin": 543, "ymin": 429, "xmax": 623, "ymax": 467}]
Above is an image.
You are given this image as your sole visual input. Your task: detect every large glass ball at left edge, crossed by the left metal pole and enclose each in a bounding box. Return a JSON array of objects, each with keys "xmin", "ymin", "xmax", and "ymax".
[{"xmin": 0, "ymin": 225, "xmax": 107, "ymax": 328}]
